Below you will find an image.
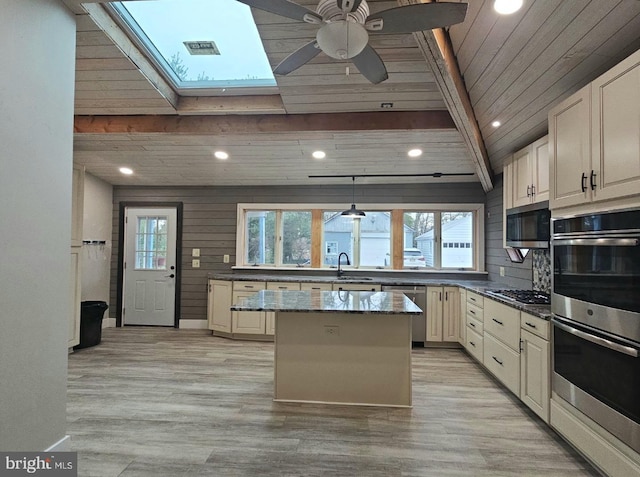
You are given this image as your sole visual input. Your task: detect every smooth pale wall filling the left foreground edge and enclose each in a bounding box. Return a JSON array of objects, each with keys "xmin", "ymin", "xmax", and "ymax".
[{"xmin": 0, "ymin": 0, "xmax": 75, "ymax": 451}]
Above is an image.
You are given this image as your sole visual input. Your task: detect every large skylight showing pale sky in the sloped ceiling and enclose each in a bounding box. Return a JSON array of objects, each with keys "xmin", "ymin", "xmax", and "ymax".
[{"xmin": 111, "ymin": 0, "xmax": 276, "ymax": 91}]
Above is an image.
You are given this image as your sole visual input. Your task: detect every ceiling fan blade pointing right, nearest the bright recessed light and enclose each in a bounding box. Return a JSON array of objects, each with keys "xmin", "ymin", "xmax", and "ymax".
[{"xmin": 365, "ymin": 2, "xmax": 467, "ymax": 33}]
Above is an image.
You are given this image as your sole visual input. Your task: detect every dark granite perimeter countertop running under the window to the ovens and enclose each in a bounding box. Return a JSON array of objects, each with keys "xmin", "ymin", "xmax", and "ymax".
[{"xmin": 209, "ymin": 273, "xmax": 551, "ymax": 320}]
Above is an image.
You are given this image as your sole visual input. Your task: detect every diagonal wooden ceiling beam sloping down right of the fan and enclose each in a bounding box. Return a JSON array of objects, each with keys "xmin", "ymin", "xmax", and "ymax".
[{"xmin": 398, "ymin": 0, "xmax": 493, "ymax": 192}]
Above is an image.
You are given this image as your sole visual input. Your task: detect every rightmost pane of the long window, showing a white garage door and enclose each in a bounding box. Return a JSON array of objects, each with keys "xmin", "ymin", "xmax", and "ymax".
[{"xmin": 442, "ymin": 212, "xmax": 473, "ymax": 268}]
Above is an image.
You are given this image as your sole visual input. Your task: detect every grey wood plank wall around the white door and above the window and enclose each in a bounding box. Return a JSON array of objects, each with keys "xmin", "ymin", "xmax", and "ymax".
[{"xmin": 109, "ymin": 183, "xmax": 484, "ymax": 320}]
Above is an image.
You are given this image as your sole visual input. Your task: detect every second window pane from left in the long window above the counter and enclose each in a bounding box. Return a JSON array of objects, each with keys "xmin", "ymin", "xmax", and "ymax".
[{"xmin": 282, "ymin": 211, "xmax": 311, "ymax": 265}]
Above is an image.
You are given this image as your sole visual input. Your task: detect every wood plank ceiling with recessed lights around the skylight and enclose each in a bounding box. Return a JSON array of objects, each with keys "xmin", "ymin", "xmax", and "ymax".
[{"xmin": 66, "ymin": 0, "xmax": 640, "ymax": 190}]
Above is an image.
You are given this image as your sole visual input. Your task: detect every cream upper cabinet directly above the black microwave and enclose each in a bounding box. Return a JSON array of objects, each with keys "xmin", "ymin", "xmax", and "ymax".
[{"xmin": 505, "ymin": 136, "xmax": 549, "ymax": 207}]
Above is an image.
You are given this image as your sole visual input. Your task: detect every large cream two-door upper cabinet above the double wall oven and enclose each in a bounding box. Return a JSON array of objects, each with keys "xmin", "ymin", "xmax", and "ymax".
[{"xmin": 549, "ymin": 51, "xmax": 640, "ymax": 209}]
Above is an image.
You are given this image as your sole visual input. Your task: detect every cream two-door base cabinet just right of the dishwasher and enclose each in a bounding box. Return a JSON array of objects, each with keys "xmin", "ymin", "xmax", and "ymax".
[{"xmin": 427, "ymin": 287, "xmax": 460, "ymax": 342}]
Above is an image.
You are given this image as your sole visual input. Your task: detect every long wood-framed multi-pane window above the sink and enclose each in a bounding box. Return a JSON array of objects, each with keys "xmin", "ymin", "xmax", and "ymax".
[{"xmin": 236, "ymin": 204, "xmax": 484, "ymax": 270}]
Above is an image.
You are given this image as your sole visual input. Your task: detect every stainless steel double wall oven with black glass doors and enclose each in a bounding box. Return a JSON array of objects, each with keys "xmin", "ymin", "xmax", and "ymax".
[{"xmin": 551, "ymin": 210, "xmax": 640, "ymax": 452}]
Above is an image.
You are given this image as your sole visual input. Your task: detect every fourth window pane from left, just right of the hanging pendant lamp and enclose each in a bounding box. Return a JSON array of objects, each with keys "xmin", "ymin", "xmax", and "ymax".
[{"xmin": 357, "ymin": 212, "xmax": 391, "ymax": 267}]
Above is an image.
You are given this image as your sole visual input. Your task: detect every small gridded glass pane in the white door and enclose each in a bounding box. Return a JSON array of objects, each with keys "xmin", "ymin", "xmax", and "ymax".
[{"xmin": 135, "ymin": 216, "xmax": 168, "ymax": 270}]
